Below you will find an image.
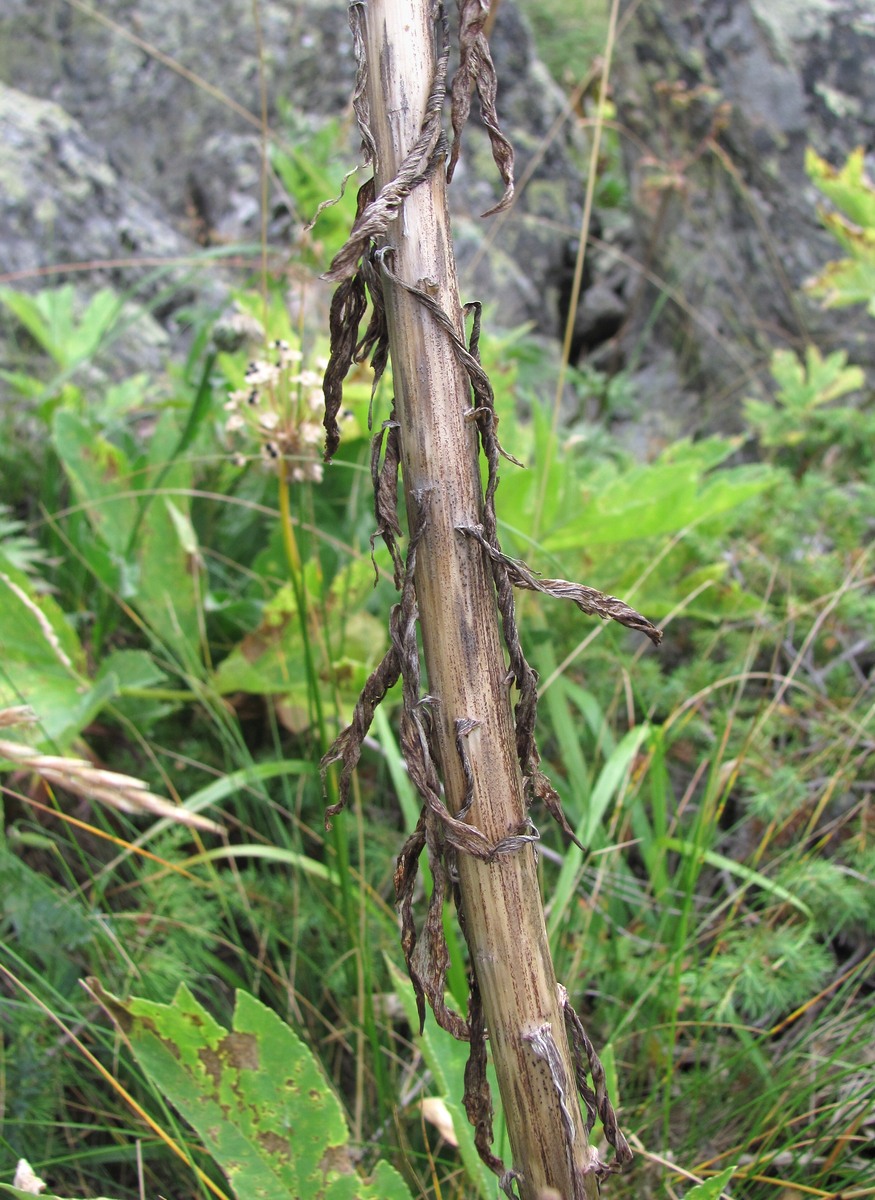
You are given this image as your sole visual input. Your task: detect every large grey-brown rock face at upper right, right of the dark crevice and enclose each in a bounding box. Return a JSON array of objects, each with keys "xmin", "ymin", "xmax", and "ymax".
[{"xmin": 613, "ymin": 0, "xmax": 875, "ymax": 427}]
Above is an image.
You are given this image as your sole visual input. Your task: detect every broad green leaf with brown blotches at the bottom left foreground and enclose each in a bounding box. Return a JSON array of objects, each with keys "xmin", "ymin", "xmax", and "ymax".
[{"xmin": 91, "ymin": 980, "xmax": 409, "ymax": 1200}]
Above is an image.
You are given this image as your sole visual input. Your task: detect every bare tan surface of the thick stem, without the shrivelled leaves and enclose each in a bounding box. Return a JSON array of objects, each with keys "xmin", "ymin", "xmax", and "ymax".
[{"xmin": 364, "ymin": 0, "xmax": 598, "ymax": 1200}]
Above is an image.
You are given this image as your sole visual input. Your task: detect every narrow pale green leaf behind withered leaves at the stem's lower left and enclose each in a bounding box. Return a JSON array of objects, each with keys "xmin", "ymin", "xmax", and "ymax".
[{"xmin": 385, "ymin": 956, "xmax": 501, "ymax": 1200}]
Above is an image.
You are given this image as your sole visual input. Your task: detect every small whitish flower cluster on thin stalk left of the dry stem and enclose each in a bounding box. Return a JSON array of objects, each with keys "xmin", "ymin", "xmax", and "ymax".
[{"xmin": 224, "ymin": 341, "xmax": 324, "ymax": 484}]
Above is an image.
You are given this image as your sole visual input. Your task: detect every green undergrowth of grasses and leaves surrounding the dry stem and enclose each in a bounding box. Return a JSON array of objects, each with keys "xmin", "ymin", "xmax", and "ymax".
[{"xmin": 0, "ymin": 142, "xmax": 875, "ymax": 1200}]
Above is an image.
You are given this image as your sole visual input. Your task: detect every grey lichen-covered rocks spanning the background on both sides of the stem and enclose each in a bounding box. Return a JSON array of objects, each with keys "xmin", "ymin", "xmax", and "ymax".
[{"xmin": 0, "ymin": 0, "xmax": 875, "ymax": 448}]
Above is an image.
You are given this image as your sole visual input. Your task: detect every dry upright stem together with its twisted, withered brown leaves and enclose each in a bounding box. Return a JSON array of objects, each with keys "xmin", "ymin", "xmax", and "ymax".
[{"xmin": 323, "ymin": 0, "xmax": 643, "ymax": 1200}]
